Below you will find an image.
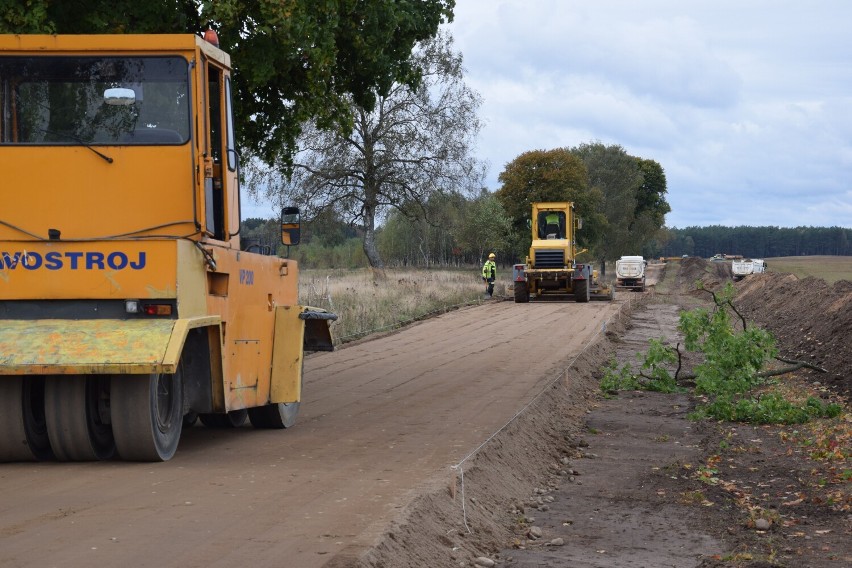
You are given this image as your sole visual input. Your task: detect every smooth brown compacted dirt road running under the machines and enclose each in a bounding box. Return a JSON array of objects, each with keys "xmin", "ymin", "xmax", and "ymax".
[{"xmin": 0, "ymin": 299, "xmax": 625, "ymax": 568}]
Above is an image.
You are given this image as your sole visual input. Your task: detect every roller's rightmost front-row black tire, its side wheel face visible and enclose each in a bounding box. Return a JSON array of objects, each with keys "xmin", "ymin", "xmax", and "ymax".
[{"xmin": 110, "ymin": 372, "xmax": 183, "ymax": 462}]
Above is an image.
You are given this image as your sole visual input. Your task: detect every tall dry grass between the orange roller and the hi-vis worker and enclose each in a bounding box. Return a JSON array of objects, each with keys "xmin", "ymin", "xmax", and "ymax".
[{"xmin": 299, "ymin": 268, "xmax": 505, "ymax": 342}]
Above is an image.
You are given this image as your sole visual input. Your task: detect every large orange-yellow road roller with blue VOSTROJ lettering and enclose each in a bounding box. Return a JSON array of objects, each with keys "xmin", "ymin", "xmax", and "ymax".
[{"xmin": 0, "ymin": 34, "xmax": 336, "ymax": 461}]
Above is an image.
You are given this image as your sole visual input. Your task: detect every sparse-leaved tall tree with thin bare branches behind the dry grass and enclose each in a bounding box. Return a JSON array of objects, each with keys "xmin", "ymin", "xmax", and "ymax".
[{"xmin": 249, "ymin": 33, "xmax": 483, "ymax": 268}]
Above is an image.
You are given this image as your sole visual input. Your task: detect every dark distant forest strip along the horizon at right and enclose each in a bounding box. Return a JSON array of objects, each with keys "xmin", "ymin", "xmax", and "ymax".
[{"xmin": 643, "ymin": 225, "xmax": 852, "ymax": 258}]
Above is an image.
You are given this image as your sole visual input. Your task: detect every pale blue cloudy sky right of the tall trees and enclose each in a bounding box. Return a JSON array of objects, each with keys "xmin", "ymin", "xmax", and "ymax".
[{"xmin": 449, "ymin": 0, "xmax": 852, "ymax": 228}]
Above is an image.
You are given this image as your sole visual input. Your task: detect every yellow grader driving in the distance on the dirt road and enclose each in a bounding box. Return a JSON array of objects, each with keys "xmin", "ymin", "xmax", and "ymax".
[{"xmin": 512, "ymin": 202, "xmax": 614, "ymax": 302}]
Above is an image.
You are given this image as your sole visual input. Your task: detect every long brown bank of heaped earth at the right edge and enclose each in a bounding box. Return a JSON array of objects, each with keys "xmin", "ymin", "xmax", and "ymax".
[{"xmin": 735, "ymin": 273, "xmax": 852, "ymax": 397}]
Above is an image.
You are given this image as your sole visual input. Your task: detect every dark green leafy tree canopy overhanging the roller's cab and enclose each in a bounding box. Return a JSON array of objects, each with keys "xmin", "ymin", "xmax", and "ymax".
[{"xmin": 0, "ymin": 0, "xmax": 455, "ymax": 162}]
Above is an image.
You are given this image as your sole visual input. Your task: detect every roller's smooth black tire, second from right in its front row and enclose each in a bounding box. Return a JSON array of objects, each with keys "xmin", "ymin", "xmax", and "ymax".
[{"xmin": 44, "ymin": 375, "xmax": 116, "ymax": 461}]
